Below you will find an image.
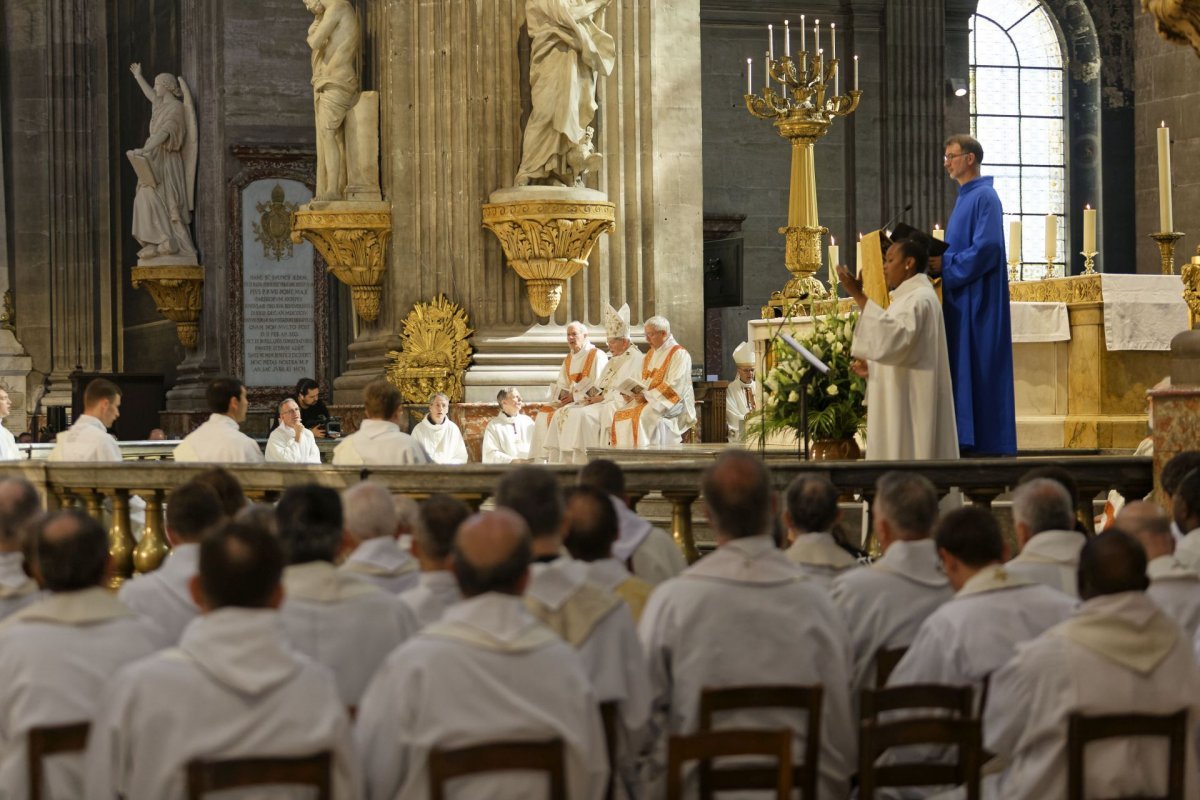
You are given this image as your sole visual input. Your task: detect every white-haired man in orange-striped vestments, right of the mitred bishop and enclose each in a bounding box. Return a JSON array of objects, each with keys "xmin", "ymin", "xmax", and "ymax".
[{"xmin": 610, "ymin": 317, "xmax": 696, "ymax": 449}]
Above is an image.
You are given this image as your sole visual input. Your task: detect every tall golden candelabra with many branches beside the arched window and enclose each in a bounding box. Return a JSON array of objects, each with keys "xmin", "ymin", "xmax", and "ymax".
[{"xmin": 745, "ymin": 43, "xmax": 863, "ymax": 317}]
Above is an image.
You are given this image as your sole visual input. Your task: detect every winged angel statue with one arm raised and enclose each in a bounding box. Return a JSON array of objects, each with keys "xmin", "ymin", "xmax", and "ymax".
[{"xmin": 125, "ymin": 64, "xmax": 197, "ymax": 264}]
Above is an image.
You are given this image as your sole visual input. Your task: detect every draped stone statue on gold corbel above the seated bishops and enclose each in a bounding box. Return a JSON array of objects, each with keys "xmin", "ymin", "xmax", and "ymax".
[{"xmin": 516, "ymin": 0, "xmax": 617, "ymax": 186}]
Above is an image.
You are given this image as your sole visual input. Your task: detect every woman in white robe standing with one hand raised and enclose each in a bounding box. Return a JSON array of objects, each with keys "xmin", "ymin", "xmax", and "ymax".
[{"xmin": 838, "ymin": 239, "xmax": 959, "ymax": 461}]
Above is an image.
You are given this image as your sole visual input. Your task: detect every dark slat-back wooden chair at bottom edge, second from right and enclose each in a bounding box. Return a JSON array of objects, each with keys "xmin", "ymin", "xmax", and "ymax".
[{"xmin": 858, "ymin": 684, "xmax": 984, "ymax": 800}]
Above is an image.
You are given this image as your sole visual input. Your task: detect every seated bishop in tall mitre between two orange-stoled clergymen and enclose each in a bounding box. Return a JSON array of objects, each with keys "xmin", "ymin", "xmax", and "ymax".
[{"xmin": 556, "ymin": 303, "xmax": 642, "ymax": 464}]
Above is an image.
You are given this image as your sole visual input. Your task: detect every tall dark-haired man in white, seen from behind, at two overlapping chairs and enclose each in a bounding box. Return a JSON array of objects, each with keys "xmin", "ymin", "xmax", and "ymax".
[{"xmin": 638, "ymin": 451, "xmax": 859, "ymax": 800}]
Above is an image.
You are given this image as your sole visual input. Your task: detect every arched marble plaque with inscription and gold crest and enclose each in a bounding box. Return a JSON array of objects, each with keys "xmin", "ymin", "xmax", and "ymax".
[{"xmin": 241, "ymin": 178, "xmax": 317, "ymax": 386}]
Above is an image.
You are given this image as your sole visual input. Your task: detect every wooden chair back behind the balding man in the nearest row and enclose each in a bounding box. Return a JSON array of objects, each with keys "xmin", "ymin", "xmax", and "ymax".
[{"xmin": 430, "ymin": 739, "xmax": 566, "ymax": 800}]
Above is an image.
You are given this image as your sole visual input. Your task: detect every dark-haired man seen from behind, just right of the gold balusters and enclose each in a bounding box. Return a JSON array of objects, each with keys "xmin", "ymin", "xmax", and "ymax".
[{"xmin": 118, "ymin": 481, "xmax": 226, "ymax": 644}]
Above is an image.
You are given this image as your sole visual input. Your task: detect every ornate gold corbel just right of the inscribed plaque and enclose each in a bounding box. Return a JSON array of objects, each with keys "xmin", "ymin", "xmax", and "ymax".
[{"xmin": 292, "ymin": 203, "xmax": 391, "ymax": 323}]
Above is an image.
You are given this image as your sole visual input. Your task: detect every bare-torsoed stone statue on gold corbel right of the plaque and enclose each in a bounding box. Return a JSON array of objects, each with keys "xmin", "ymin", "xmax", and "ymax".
[{"xmin": 304, "ymin": 0, "xmax": 361, "ymax": 200}]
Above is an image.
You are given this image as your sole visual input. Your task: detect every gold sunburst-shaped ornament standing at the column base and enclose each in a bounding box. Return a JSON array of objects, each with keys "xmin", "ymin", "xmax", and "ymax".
[{"xmin": 388, "ymin": 295, "xmax": 474, "ymax": 404}]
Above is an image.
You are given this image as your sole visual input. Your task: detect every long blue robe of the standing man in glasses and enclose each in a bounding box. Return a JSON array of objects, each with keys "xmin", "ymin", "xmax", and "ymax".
[{"xmin": 942, "ymin": 178, "xmax": 1016, "ymax": 456}]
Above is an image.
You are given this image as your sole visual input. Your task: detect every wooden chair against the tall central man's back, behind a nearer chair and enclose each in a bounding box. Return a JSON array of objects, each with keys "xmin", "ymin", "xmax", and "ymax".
[{"xmin": 700, "ymin": 686, "xmax": 823, "ymax": 800}]
